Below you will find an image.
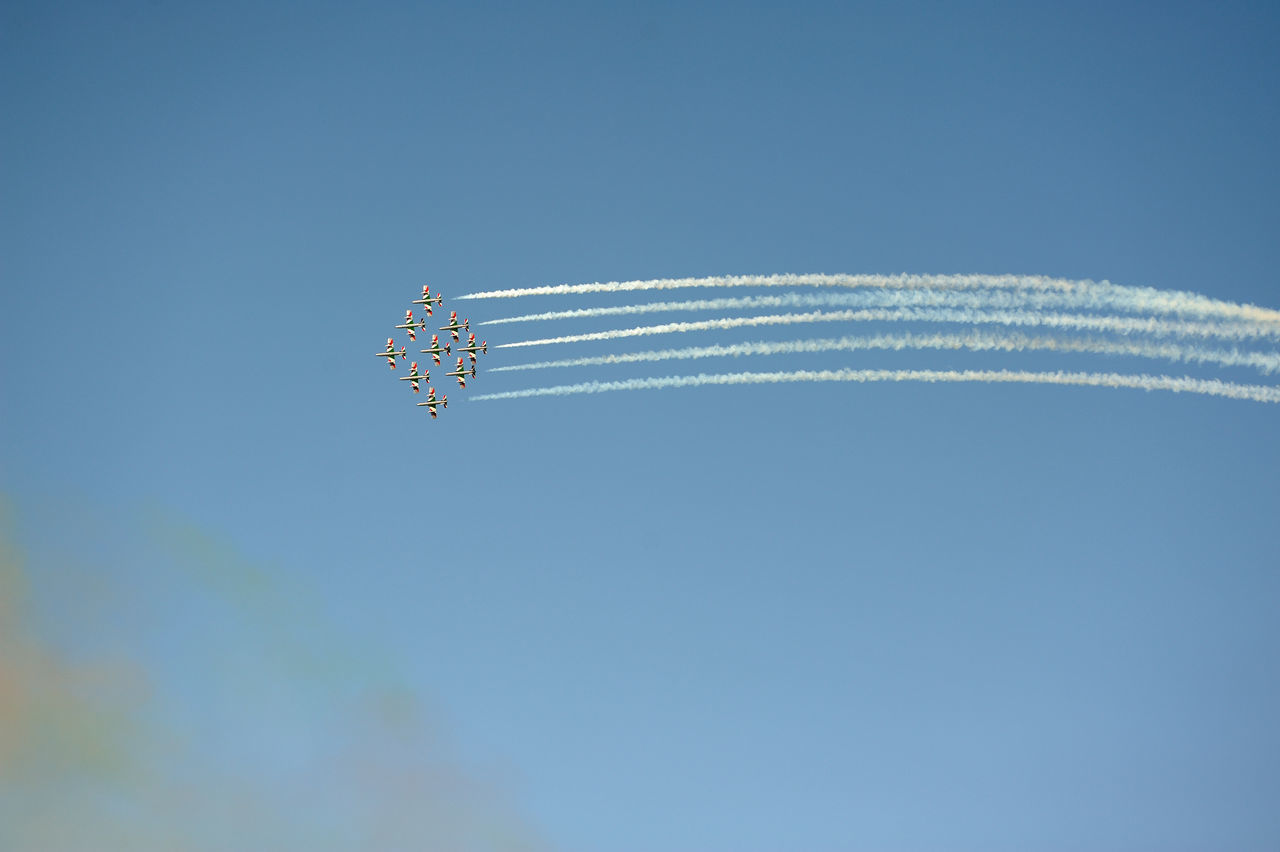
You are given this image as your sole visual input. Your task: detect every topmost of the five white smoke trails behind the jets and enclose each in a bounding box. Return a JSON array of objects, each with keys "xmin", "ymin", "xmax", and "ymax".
[{"xmin": 457, "ymin": 275, "xmax": 1280, "ymax": 325}]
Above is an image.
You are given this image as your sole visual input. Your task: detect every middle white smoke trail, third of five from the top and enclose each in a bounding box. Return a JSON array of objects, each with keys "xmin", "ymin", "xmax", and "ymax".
[{"xmin": 499, "ymin": 308, "xmax": 1272, "ymax": 348}]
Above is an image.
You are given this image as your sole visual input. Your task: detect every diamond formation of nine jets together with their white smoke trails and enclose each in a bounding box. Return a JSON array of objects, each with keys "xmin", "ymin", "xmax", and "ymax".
[{"xmin": 379, "ymin": 275, "xmax": 1280, "ymax": 417}]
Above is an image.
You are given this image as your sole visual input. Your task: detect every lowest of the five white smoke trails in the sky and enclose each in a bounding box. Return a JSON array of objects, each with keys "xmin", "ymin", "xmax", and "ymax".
[{"xmin": 470, "ymin": 370, "xmax": 1280, "ymax": 403}]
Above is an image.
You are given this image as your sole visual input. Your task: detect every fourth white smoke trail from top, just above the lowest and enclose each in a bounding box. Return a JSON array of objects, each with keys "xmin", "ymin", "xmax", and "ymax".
[{"xmin": 489, "ymin": 331, "xmax": 1280, "ymax": 374}]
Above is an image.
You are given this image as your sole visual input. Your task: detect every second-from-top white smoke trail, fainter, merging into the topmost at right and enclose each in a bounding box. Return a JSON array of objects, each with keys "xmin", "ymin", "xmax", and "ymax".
[{"xmin": 480, "ymin": 289, "xmax": 1280, "ymax": 324}]
